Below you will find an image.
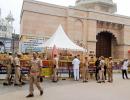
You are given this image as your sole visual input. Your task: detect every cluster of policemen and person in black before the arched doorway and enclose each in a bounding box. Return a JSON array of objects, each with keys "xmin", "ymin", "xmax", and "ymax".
[{"xmin": 95, "ymin": 56, "xmax": 114, "ymax": 83}]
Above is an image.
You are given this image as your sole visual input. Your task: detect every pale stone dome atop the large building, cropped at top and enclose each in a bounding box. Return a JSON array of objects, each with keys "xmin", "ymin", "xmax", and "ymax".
[{"xmin": 75, "ymin": 0, "xmax": 117, "ymax": 13}]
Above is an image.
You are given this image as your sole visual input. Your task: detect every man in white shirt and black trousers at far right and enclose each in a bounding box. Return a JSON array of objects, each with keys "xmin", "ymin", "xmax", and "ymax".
[{"xmin": 122, "ymin": 59, "xmax": 129, "ymax": 79}]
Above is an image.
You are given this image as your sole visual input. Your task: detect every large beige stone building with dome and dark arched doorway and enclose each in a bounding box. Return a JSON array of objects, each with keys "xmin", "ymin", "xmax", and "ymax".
[{"xmin": 20, "ymin": 0, "xmax": 130, "ymax": 58}]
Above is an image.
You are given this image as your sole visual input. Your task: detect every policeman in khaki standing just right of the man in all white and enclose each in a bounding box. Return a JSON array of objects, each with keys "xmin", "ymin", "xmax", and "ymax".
[{"xmin": 83, "ymin": 57, "xmax": 89, "ymax": 82}]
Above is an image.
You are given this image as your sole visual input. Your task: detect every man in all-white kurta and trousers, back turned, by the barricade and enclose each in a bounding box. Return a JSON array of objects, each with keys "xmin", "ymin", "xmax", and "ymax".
[{"xmin": 72, "ymin": 56, "xmax": 80, "ymax": 81}]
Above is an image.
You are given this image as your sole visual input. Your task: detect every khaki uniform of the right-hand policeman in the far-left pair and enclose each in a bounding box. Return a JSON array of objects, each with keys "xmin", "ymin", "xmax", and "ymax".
[{"xmin": 14, "ymin": 57, "xmax": 21, "ymax": 84}]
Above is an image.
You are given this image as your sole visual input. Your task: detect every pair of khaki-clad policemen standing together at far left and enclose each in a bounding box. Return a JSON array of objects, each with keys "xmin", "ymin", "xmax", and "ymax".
[{"xmin": 4, "ymin": 52, "xmax": 21, "ymax": 86}]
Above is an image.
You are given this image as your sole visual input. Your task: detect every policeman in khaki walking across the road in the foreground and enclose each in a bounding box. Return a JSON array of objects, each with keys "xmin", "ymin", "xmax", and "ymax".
[{"xmin": 26, "ymin": 53, "xmax": 43, "ymax": 97}]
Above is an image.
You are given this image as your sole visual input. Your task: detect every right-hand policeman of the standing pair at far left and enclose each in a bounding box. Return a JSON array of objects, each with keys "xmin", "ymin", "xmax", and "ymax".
[{"xmin": 14, "ymin": 53, "xmax": 21, "ymax": 86}]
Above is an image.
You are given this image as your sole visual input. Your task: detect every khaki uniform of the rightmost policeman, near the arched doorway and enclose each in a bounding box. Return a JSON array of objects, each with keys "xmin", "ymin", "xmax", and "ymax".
[{"xmin": 107, "ymin": 60, "xmax": 113, "ymax": 82}]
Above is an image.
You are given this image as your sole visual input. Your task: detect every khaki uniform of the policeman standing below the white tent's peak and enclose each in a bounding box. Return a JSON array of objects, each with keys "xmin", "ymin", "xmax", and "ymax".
[{"xmin": 52, "ymin": 57, "xmax": 59, "ymax": 81}]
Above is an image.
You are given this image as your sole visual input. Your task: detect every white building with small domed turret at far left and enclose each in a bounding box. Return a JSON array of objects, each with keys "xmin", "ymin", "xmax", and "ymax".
[{"xmin": 0, "ymin": 9, "xmax": 14, "ymax": 53}]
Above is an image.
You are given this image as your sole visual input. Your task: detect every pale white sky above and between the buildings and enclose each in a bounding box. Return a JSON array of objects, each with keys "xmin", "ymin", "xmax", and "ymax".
[{"xmin": 0, "ymin": 0, "xmax": 130, "ymax": 33}]
